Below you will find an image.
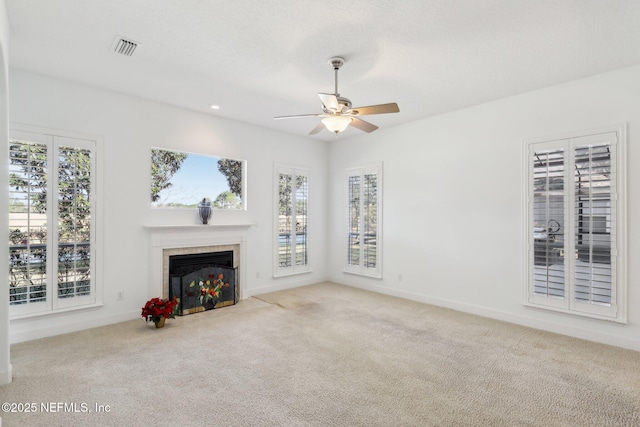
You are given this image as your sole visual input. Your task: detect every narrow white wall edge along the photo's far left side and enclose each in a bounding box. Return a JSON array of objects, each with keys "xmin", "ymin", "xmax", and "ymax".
[{"xmin": 0, "ymin": 0, "xmax": 11, "ymax": 385}]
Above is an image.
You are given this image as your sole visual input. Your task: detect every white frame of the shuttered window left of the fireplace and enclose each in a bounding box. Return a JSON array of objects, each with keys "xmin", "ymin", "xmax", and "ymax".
[{"xmin": 9, "ymin": 123, "xmax": 103, "ymax": 319}]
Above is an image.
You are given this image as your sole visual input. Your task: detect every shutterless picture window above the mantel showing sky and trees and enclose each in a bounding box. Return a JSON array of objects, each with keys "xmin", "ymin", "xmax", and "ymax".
[{"xmin": 151, "ymin": 148, "xmax": 246, "ymax": 210}]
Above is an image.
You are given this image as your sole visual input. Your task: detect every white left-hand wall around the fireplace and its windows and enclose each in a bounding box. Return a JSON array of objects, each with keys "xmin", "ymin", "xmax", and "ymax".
[{"xmin": 9, "ymin": 69, "xmax": 328, "ymax": 342}]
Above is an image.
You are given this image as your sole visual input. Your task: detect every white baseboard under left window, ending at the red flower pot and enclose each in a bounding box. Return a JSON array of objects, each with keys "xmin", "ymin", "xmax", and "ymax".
[{"xmin": 9, "ymin": 310, "xmax": 140, "ymax": 344}]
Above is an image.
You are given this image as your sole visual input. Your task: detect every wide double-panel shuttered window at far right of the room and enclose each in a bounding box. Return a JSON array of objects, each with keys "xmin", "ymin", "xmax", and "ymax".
[{"xmin": 525, "ymin": 129, "xmax": 626, "ymax": 321}]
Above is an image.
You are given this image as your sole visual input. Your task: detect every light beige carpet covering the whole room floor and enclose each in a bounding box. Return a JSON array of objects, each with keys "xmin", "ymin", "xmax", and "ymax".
[{"xmin": 0, "ymin": 283, "xmax": 640, "ymax": 427}]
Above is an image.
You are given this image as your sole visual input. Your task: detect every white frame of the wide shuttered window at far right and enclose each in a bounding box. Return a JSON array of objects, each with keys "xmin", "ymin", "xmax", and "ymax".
[{"xmin": 522, "ymin": 124, "xmax": 627, "ymax": 323}]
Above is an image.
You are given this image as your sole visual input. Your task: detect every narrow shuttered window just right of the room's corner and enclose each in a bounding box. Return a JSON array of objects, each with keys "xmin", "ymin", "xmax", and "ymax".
[{"xmin": 345, "ymin": 164, "xmax": 382, "ymax": 278}]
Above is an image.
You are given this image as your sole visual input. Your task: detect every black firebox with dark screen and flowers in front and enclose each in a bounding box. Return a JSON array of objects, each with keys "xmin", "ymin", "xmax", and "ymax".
[{"xmin": 169, "ymin": 250, "xmax": 238, "ymax": 316}]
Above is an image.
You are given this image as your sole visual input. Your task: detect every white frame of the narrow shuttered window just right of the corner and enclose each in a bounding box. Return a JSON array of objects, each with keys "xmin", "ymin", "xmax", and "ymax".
[{"xmin": 343, "ymin": 162, "xmax": 383, "ymax": 279}]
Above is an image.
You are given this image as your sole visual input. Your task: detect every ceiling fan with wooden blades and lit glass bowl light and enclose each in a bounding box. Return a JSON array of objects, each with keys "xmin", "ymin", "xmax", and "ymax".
[{"xmin": 274, "ymin": 56, "xmax": 400, "ymax": 135}]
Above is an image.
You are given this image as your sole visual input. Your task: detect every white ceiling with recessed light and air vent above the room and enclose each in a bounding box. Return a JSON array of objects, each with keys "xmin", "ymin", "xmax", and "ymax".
[{"xmin": 6, "ymin": 0, "xmax": 640, "ymax": 140}]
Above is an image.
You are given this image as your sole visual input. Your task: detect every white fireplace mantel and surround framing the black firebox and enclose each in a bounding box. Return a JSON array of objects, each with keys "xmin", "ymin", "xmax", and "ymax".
[{"xmin": 145, "ymin": 223, "xmax": 254, "ymax": 300}]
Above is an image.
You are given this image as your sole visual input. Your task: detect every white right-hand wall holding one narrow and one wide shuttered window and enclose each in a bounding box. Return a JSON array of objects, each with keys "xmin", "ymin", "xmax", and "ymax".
[{"xmin": 328, "ymin": 66, "xmax": 640, "ymax": 350}]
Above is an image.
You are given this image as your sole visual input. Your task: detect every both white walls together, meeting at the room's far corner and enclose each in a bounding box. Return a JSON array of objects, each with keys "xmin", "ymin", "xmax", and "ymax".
[{"xmin": 6, "ymin": 61, "xmax": 640, "ymax": 352}]
